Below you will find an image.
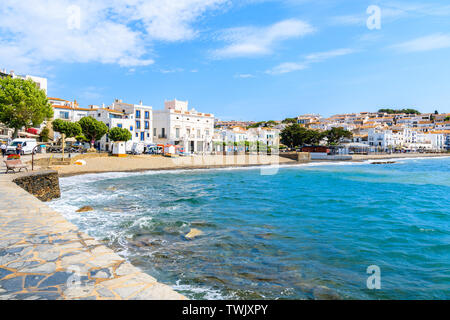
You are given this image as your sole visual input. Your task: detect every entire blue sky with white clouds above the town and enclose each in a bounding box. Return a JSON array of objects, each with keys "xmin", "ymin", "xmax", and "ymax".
[{"xmin": 0, "ymin": 0, "xmax": 450, "ymax": 121}]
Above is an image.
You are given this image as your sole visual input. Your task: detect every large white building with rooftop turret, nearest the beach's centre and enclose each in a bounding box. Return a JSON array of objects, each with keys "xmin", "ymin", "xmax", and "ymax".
[{"xmin": 153, "ymin": 100, "xmax": 214, "ymax": 153}]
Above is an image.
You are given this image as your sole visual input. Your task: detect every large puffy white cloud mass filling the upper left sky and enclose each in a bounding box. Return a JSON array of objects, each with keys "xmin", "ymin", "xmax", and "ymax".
[{"xmin": 0, "ymin": 0, "xmax": 228, "ymax": 72}]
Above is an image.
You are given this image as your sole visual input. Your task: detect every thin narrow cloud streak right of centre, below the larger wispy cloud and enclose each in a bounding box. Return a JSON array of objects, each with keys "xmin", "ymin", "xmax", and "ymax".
[{"xmin": 266, "ymin": 49, "xmax": 355, "ymax": 75}]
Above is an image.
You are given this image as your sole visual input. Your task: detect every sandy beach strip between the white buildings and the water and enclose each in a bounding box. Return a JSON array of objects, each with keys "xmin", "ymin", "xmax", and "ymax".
[{"xmin": 51, "ymin": 155, "xmax": 298, "ymax": 176}]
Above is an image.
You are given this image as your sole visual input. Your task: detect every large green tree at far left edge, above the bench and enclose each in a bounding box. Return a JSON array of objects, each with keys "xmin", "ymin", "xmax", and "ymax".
[{"xmin": 0, "ymin": 77, "xmax": 53, "ymax": 138}]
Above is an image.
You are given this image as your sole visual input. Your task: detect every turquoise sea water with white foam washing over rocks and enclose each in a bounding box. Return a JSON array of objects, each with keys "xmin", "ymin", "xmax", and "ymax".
[{"xmin": 51, "ymin": 158, "xmax": 450, "ymax": 299}]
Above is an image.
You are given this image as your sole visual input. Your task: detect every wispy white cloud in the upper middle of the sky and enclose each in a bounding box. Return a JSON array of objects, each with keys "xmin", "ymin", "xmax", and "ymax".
[{"xmin": 213, "ymin": 19, "xmax": 315, "ymax": 59}]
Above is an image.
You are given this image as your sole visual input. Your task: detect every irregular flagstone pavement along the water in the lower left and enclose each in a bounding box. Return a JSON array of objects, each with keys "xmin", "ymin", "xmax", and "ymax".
[{"xmin": 0, "ymin": 173, "xmax": 185, "ymax": 300}]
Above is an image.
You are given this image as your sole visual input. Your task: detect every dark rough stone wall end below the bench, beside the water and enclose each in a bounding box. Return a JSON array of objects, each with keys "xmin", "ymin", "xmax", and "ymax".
[{"xmin": 13, "ymin": 170, "xmax": 61, "ymax": 201}]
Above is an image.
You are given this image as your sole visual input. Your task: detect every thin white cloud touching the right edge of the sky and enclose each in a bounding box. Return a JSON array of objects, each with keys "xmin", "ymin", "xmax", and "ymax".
[{"xmin": 391, "ymin": 33, "xmax": 450, "ymax": 52}]
